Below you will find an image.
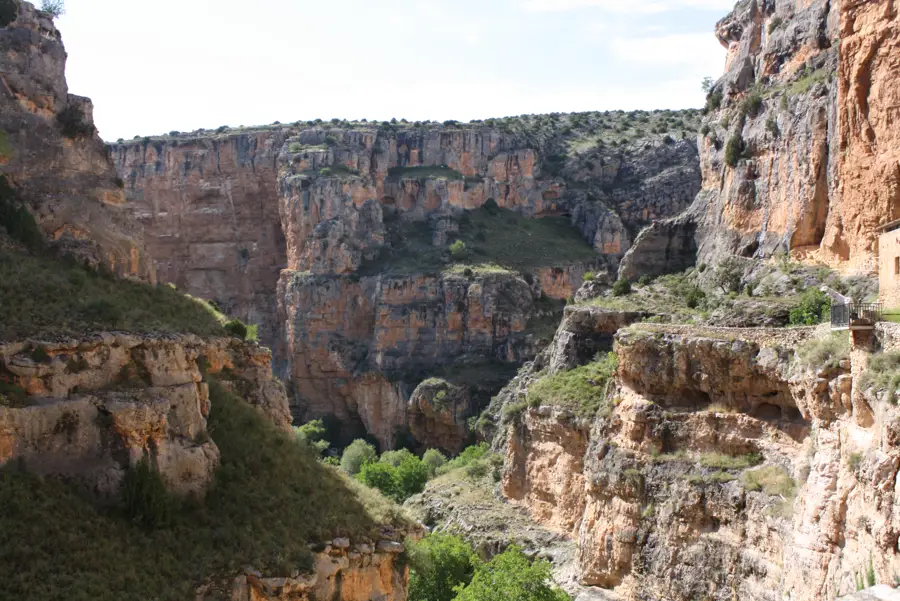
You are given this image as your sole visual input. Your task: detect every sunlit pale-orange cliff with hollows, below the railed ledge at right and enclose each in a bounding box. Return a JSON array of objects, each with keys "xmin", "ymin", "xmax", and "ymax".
[{"xmin": 492, "ymin": 309, "xmax": 900, "ymax": 601}]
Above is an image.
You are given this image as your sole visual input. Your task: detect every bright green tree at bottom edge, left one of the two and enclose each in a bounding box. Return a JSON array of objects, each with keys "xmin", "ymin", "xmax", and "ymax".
[{"xmin": 409, "ymin": 534, "xmax": 479, "ymax": 601}]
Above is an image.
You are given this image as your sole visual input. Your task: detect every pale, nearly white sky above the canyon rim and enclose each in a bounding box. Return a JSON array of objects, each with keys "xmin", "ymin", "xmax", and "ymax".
[{"xmin": 58, "ymin": 0, "xmax": 734, "ymax": 140}]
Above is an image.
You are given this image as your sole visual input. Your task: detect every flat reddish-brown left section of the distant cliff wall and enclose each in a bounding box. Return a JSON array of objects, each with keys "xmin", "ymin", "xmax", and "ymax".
[{"xmin": 113, "ymin": 129, "xmax": 286, "ymax": 344}]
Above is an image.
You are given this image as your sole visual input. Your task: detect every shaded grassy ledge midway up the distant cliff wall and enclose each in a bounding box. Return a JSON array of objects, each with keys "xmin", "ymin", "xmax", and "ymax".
[{"xmin": 361, "ymin": 204, "xmax": 598, "ymax": 275}]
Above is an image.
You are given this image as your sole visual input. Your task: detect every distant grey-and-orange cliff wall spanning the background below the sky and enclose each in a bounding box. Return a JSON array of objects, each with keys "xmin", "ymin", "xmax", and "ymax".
[{"xmin": 113, "ymin": 113, "xmax": 700, "ymax": 451}]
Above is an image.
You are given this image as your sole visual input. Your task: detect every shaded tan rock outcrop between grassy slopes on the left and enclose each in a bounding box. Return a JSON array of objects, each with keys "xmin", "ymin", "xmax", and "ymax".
[{"xmin": 0, "ymin": 333, "xmax": 291, "ymax": 494}]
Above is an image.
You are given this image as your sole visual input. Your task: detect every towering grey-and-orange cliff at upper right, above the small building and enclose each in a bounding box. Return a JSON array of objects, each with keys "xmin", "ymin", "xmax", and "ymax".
[{"xmin": 626, "ymin": 0, "xmax": 900, "ymax": 271}]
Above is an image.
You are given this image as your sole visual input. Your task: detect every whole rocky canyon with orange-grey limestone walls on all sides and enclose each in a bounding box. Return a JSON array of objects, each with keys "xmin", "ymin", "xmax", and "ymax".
[{"xmin": 0, "ymin": 0, "xmax": 900, "ymax": 601}]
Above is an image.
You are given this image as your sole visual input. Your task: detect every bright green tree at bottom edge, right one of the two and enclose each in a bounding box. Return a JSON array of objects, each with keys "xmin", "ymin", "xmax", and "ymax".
[{"xmin": 454, "ymin": 547, "xmax": 569, "ymax": 601}]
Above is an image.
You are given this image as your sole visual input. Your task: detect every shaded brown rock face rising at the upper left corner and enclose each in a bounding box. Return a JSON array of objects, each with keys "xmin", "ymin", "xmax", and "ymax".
[{"xmin": 0, "ymin": 1, "xmax": 153, "ymax": 280}]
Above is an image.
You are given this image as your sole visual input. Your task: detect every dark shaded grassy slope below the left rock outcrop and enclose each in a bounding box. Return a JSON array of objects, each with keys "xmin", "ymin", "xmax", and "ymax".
[{"xmin": 0, "ymin": 383, "xmax": 405, "ymax": 601}]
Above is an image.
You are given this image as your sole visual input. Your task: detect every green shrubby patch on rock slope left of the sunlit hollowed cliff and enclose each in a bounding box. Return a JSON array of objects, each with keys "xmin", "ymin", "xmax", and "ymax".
[{"xmin": 528, "ymin": 353, "xmax": 618, "ymax": 417}]
